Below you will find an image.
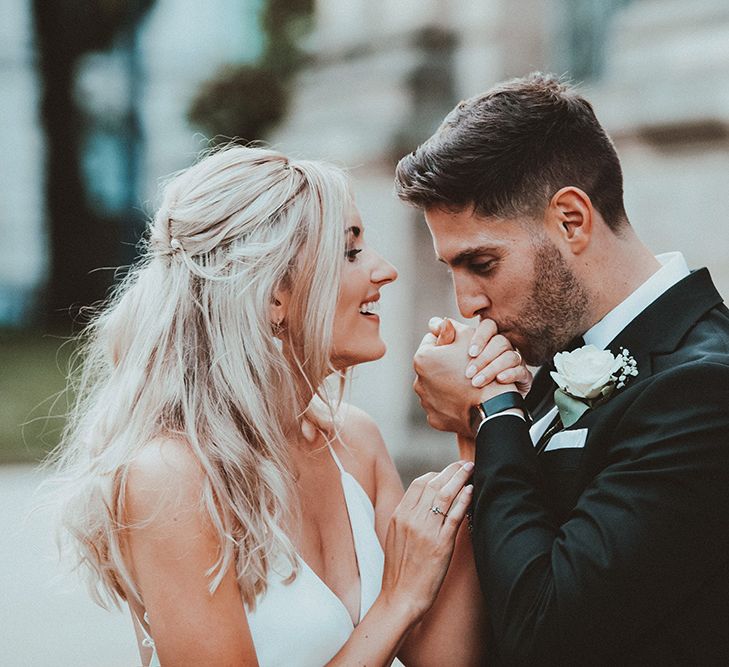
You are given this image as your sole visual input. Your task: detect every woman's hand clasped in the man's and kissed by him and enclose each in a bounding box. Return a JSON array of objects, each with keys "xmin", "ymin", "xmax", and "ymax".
[{"xmin": 428, "ymin": 317, "xmax": 533, "ymax": 396}]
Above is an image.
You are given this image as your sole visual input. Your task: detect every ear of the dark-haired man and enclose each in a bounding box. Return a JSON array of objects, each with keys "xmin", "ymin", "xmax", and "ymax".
[{"xmin": 545, "ymin": 185, "xmax": 596, "ymax": 255}]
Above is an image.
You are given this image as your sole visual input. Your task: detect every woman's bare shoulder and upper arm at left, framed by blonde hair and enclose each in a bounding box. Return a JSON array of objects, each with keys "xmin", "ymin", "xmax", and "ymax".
[{"xmin": 125, "ymin": 441, "xmax": 258, "ymax": 667}]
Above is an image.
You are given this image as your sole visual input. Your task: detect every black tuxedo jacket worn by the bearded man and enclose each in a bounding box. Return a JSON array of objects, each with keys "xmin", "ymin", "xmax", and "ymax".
[{"xmin": 473, "ymin": 269, "xmax": 729, "ymax": 667}]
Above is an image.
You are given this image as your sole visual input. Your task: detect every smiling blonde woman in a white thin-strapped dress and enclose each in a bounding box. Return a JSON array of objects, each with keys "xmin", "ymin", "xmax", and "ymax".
[{"xmin": 52, "ymin": 146, "xmax": 524, "ymax": 666}]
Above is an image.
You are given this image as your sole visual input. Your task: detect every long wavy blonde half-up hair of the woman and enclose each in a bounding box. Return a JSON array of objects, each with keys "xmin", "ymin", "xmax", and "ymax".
[{"xmin": 54, "ymin": 146, "xmax": 350, "ymax": 606}]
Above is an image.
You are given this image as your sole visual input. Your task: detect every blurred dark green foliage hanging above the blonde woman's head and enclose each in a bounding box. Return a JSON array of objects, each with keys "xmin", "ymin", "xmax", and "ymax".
[{"xmin": 188, "ymin": 0, "xmax": 314, "ymax": 142}]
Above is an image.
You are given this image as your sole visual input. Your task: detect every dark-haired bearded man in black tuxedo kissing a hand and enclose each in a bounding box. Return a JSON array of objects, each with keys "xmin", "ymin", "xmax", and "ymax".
[{"xmin": 397, "ymin": 74, "xmax": 729, "ymax": 667}]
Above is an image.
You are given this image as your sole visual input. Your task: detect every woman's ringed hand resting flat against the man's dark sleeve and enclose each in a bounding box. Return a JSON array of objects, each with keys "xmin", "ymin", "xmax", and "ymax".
[{"xmin": 382, "ymin": 461, "xmax": 473, "ymax": 623}]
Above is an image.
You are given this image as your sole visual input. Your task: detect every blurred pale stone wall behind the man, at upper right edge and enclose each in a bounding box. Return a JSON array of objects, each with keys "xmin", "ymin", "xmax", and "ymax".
[{"xmin": 588, "ymin": 0, "xmax": 729, "ymax": 298}]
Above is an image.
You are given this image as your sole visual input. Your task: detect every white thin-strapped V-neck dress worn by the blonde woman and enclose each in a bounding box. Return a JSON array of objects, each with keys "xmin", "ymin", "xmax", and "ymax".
[{"xmin": 139, "ymin": 446, "xmax": 385, "ymax": 667}]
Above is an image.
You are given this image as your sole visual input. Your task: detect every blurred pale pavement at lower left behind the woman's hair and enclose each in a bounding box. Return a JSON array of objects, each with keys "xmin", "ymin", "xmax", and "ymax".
[{"xmin": 0, "ymin": 465, "xmax": 140, "ymax": 667}]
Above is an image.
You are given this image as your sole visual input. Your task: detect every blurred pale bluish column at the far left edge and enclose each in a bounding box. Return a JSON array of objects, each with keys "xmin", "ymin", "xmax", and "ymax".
[{"xmin": 0, "ymin": 0, "xmax": 48, "ymax": 327}]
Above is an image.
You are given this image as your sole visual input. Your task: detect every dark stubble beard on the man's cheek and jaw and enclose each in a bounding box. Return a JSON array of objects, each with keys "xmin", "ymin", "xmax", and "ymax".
[{"xmin": 498, "ymin": 239, "xmax": 590, "ymax": 366}]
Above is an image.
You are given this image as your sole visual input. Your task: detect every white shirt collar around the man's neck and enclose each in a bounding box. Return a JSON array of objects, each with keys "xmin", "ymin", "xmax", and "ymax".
[{"xmin": 584, "ymin": 252, "xmax": 690, "ymax": 350}]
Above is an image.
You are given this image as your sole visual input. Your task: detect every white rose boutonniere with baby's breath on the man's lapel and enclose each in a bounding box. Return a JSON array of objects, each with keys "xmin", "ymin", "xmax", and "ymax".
[{"xmin": 551, "ymin": 345, "xmax": 638, "ymax": 428}]
